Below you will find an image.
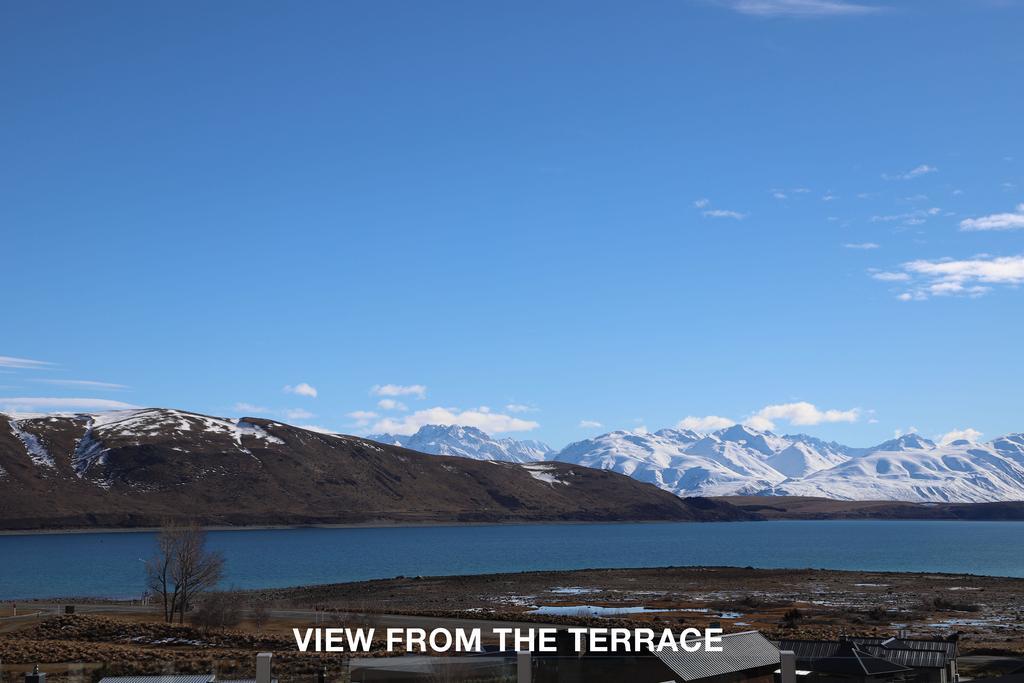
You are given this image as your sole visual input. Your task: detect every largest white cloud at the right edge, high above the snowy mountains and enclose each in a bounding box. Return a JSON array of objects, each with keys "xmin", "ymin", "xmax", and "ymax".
[{"xmin": 872, "ymin": 255, "xmax": 1024, "ymax": 301}]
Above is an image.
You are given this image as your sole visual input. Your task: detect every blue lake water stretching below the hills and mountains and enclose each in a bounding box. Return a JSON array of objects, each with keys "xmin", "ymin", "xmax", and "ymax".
[{"xmin": 0, "ymin": 520, "xmax": 1024, "ymax": 600}]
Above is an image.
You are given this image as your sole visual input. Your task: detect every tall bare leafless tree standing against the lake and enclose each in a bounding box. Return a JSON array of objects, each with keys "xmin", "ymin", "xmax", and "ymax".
[{"xmin": 145, "ymin": 522, "xmax": 224, "ymax": 623}]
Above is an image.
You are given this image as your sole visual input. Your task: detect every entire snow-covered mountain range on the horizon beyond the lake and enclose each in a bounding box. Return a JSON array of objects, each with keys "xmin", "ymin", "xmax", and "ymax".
[{"xmin": 370, "ymin": 425, "xmax": 1024, "ymax": 503}]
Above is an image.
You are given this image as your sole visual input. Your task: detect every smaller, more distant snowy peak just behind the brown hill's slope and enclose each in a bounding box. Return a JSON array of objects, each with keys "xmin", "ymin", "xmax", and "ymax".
[{"xmin": 367, "ymin": 425, "xmax": 554, "ymax": 463}]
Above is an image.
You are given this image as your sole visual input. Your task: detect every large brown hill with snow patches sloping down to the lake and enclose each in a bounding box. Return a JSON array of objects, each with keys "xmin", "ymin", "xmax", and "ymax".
[{"xmin": 0, "ymin": 409, "xmax": 756, "ymax": 529}]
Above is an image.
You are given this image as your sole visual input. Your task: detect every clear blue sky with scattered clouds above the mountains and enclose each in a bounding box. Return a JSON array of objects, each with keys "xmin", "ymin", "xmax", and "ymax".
[{"xmin": 0, "ymin": 0, "xmax": 1024, "ymax": 445}]
